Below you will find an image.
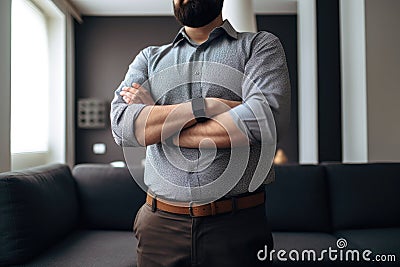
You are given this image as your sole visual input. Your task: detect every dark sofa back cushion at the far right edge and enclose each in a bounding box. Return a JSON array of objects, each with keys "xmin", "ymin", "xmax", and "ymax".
[{"xmin": 326, "ymin": 163, "xmax": 400, "ymax": 230}]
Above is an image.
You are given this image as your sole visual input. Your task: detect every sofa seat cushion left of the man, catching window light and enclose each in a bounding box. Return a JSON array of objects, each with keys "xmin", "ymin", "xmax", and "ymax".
[{"xmin": 24, "ymin": 230, "xmax": 137, "ymax": 267}]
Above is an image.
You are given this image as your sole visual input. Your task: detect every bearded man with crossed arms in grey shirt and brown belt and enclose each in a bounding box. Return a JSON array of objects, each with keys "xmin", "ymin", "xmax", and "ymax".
[{"xmin": 111, "ymin": 0, "xmax": 290, "ymax": 267}]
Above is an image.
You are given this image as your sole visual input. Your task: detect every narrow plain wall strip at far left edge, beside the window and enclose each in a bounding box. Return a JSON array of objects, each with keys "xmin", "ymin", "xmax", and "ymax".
[{"xmin": 0, "ymin": 0, "xmax": 11, "ymax": 172}]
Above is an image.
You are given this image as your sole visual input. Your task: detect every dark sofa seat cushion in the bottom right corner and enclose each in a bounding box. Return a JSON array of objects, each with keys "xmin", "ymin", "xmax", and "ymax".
[{"xmin": 335, "ymin": 228, "xmax": 400, "ymax": 266}]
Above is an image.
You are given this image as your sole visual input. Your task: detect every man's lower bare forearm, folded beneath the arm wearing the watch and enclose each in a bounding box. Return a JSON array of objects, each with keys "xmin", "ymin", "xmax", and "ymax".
[{"xmin": 175, "ymin": 112, "xmax": 249, "ymax": 148}]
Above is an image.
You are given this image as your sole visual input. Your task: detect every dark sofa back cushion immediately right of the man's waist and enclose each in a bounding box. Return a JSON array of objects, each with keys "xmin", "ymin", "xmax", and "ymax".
[{"xmin": 266, "ymin": 165, "xmax": 332, "ymax": 232}]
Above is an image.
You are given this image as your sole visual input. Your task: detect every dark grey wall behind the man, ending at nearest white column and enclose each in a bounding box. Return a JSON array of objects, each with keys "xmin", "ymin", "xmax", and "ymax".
[{"xmin": 75, "ymin": 15, "xmax": 298, "ymax": 163}]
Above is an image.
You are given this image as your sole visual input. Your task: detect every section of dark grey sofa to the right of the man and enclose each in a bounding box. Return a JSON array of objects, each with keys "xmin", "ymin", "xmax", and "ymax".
[{"xmin": 266, "ymin": 163, "xmax": 400, "ymax": 266}]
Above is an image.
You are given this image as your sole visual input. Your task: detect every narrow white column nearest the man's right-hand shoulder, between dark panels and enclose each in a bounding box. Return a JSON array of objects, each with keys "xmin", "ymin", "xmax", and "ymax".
[{"xmin": 297, "ymin": 0, "xmax": 318, "ymax": 164}]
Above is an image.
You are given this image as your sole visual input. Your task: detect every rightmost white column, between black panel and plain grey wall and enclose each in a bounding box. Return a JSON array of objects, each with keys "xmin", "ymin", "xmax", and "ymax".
[{"xmin": 340, "ymin": 0, "xmax": 368, "ymax": 162}]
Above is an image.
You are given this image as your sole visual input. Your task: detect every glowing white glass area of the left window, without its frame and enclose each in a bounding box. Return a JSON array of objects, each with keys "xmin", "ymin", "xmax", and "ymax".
[{"xmin": 11, "ymin": 0, "xmax": 49, "ymax": 154}]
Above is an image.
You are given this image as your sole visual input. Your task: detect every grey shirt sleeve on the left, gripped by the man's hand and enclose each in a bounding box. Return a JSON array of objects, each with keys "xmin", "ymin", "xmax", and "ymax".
[{"xmin": 110, "ymin": 49, "xmax": 150, "ymax": 146}]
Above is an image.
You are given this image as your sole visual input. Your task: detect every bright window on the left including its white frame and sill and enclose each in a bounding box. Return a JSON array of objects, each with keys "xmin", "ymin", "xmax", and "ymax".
[{"xmin": 11, "ymin": 0, "xmax": 66, "ymax": 170}]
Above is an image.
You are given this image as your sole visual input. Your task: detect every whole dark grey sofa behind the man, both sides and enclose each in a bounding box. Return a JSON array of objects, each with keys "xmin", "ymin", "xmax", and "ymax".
[{"xmin": 0, "ymin": 163, "xmax": 400, "ymax": 267}]
